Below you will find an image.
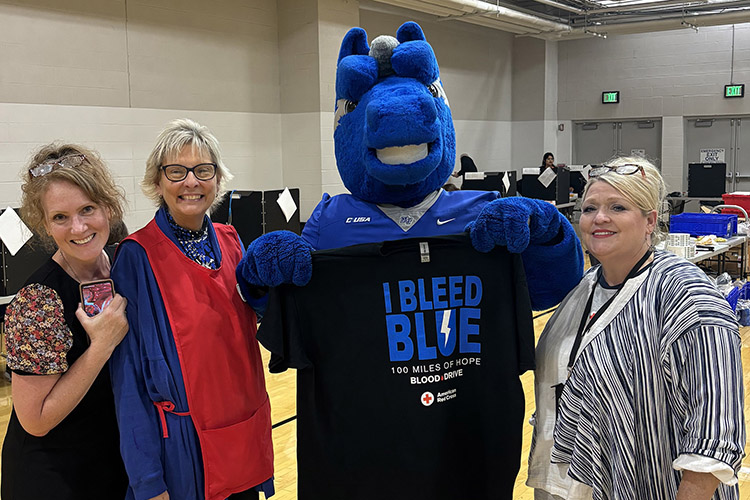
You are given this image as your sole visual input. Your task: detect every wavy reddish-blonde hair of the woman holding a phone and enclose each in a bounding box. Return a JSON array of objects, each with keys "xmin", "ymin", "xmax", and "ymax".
[{"xmin": 20, "ymin": 143, "xmax": 125, "ymax": 248}]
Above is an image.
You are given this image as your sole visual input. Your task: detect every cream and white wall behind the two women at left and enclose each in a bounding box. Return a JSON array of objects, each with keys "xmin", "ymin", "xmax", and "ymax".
[{"xmin": 0, "ymin": 0, "xmax": 283, "ymax": 230}]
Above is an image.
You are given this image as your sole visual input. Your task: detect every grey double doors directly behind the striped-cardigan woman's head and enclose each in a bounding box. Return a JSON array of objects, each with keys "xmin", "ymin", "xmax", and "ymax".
[{"xmin": 573, "ymin": 120, "xmax": 661, "ymax": 168}]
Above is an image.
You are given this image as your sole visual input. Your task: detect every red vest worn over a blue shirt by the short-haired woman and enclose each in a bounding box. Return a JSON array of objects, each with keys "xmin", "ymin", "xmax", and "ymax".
[{"xmin": 130, "ymin": 220, "xmax": 273, "ymax": 500}]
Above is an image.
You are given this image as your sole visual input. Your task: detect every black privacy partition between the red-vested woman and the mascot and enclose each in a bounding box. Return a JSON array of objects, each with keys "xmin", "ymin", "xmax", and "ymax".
[{"xmin": 211, "ymin": 188, "xmax": 300, "ymax": 246}]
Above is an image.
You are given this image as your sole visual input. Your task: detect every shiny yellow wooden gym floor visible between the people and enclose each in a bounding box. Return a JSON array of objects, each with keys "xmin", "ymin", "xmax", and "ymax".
[{"xmin": 0, "ymin": 320, "xmax": 750, "ymax": 500}]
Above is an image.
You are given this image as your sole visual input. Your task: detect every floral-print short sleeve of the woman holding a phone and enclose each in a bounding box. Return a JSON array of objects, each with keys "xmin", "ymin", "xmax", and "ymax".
[{"xmin": 5, "ymin": 284, "xmax": 73, "ymax": 375}]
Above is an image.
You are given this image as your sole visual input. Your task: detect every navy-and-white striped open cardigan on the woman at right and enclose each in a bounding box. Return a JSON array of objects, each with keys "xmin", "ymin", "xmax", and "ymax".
[{"xmin": 528, "ymin": 251, "xmax": 745, "ymax": 500}]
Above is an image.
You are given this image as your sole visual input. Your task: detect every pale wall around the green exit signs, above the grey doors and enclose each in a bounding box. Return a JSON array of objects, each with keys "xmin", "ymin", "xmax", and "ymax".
[{"xmin": 558, "ymin": 24, "xmax": 750, "ymax": 191}]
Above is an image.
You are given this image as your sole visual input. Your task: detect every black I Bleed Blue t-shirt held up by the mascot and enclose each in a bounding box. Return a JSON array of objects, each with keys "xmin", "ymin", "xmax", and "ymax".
[{"xmin": 258, "ymin": 235, "xmax": 534, "ymax": 500}]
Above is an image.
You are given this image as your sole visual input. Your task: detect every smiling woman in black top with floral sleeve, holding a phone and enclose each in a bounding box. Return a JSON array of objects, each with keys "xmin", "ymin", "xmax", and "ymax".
[{"xmin": 2, "ymin": 144, "xmax": 128, "ymax": 500}]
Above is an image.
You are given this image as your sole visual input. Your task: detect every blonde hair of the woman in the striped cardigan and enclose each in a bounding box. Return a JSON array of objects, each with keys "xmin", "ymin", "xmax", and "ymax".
[{"xmin": 583, "ymin": 156, "xmax": 667, "ymax": 245}]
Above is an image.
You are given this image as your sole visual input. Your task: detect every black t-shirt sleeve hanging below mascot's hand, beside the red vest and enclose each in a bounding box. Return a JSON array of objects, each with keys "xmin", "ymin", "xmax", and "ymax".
[{"xmin": 257, "ymin": 285, "xmax": 312, "ymax": 373}]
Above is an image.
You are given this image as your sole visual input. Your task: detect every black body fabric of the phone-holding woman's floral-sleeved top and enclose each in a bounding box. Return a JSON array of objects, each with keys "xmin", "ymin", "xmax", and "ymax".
[{"xmin": 1, "ymin": 259, "xmax": 127, "ymax": 500}]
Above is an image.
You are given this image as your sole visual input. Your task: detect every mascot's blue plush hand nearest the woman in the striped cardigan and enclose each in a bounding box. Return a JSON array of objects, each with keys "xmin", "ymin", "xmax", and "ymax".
[{"xmin": 466, "ymin": 196, "xmax": 563, "ymax": 253}]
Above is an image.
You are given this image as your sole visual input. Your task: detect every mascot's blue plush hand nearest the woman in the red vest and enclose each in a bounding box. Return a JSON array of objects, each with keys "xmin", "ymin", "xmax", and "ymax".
[{"xmin": 237, "ymin": 231, "xmax": 313, "ymax": 286}]
